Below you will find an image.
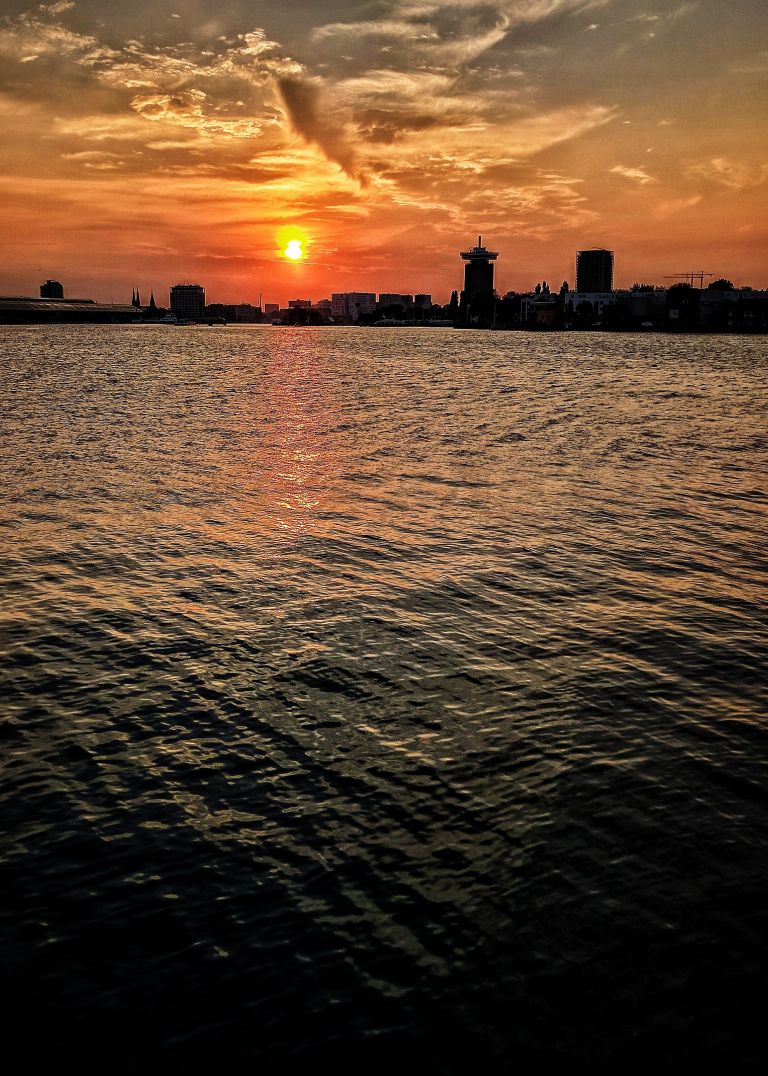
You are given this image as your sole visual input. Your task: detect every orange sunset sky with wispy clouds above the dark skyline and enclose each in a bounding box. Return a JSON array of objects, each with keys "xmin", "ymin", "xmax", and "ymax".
[{"xmin": 0, "ymin": 0, "xmax": 768, "ymax": 303}]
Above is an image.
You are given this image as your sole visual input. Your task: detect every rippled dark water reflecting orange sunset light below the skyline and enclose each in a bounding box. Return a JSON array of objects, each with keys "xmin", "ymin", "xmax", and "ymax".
[{"xmin": 0, "ymin": 327, "xmax": 768, "ymax": 1073}]
